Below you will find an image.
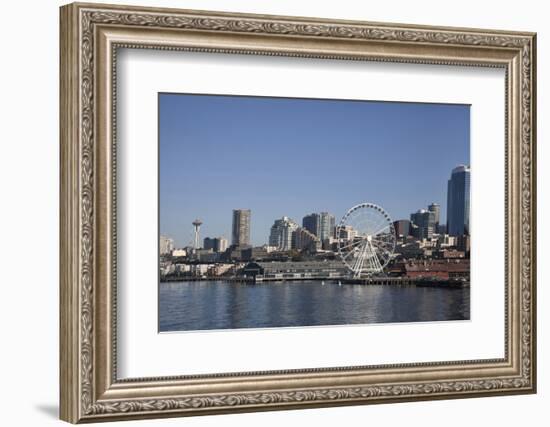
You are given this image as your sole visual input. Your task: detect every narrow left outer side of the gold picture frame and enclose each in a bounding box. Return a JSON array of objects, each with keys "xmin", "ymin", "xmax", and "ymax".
[{"xmin": 59, "ymin": 5, "xmax": 80, "ymax": 423}]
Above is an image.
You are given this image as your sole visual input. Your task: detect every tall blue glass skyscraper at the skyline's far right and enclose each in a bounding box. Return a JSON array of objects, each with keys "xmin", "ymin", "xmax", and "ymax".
[{"xmin": 447, "ymin": 165, "xmax": 470, "ymax": 236}]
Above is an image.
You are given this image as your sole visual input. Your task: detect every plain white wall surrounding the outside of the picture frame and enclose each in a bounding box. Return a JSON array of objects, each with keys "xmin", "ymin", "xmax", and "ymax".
[{"xmin": 0, "ymin": 0, "xmax": 550, "ymax": 427}]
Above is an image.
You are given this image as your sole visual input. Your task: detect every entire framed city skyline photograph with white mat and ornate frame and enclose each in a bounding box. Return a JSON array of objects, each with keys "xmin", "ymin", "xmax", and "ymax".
[{"xmin": 60, "ymin": 4, "xmax": 536, "ymax": 423}]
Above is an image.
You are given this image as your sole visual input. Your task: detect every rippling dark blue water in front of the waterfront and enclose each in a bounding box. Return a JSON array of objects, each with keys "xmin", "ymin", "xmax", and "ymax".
[{"xmin": 159, "ymin": 281, "xmax": 470, "ymax": 332}]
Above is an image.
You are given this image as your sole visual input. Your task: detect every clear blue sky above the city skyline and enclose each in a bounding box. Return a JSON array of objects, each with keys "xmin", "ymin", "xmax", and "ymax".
[{"xmin": 159, "ymin": 94, "xmax": 470, "ymax": 247}]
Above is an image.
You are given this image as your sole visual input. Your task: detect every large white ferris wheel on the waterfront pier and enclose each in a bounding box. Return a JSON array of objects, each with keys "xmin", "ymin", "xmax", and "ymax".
[{"xmin": 336, "ymin": 203, "xmax": 395, "ymax": 278}]
